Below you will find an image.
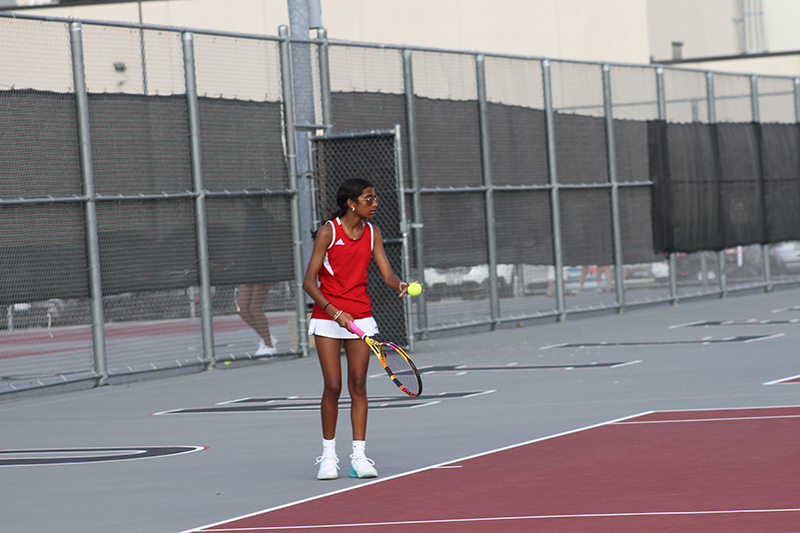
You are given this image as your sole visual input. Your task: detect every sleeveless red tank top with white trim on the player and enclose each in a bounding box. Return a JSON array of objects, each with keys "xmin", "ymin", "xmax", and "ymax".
[{"xmin": 311, "ymin": 218, "xmax": 375, "ymax": 320}]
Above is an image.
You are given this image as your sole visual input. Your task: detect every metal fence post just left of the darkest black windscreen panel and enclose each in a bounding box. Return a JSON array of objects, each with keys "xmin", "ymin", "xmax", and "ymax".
[{"xmin": 603, "ymin": 65, "xmax": 625, "ymax": 313}]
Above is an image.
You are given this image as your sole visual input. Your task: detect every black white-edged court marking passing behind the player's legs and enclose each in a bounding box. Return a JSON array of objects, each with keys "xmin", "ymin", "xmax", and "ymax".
[{"xmin": 153, "ymin": 390, "xmax": 497, "ymax": 415}]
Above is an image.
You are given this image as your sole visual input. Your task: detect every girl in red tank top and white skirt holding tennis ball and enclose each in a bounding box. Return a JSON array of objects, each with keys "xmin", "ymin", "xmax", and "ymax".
[{"xmin": 303, "ymin": 178, "xmax": 408, "ymax": 479}]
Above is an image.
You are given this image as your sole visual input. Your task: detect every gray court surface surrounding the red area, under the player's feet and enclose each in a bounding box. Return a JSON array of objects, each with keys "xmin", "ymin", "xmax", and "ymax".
[{"xmin": 0, "ymin": 289, "xmax": 800, "ymax": 533}]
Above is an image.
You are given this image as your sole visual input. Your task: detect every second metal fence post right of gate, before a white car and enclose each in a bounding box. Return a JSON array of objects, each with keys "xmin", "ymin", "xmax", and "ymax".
[{"xmin": 475, "ymin": 54, "xmax": 500, "ymax": 329}]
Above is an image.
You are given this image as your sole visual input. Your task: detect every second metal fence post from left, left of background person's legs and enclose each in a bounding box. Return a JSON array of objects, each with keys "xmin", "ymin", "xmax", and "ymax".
[{"xmin": 181, "ymin": 31, "xmax": 215, "ymax": 368}]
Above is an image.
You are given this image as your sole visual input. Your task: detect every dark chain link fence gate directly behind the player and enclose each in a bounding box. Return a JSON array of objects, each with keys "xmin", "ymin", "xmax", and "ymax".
[{"xmin": 310, "ymin": 126, "xmax": 413, "ymax": 348}]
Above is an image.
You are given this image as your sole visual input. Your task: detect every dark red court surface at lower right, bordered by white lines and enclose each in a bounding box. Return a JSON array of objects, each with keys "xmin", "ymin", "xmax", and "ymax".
[{"xmin": 186, "ymin": 407, "xmax": 800, "ymax": 533}]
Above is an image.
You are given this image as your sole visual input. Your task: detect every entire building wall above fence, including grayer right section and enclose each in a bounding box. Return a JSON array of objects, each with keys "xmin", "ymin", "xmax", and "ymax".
[{"xmin": 15, "ymin": 0, "xmax": 800, "ymax": 75}]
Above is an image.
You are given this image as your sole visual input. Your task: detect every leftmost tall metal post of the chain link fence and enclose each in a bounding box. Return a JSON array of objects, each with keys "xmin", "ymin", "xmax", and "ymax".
[{"xmin": 69, "ymin": 22, "xmax": 108, "ymax": 386}]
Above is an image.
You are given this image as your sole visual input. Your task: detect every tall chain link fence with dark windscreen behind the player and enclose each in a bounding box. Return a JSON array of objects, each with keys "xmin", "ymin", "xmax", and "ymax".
[{"xmin": 0, "ymin": 14, "xmax": 800, "ymax": 397}]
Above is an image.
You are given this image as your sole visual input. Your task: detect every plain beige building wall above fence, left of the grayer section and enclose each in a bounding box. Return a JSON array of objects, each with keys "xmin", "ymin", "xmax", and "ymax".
[{"xmin": 25, "ymin": 0, "xmax": 650, "ymax": 63}]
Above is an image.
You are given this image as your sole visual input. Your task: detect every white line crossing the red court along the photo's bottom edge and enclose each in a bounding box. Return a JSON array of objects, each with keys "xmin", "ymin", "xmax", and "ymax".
[{"xmin": 195, "ymin": 509, "xmax": 800, "ymax": 533}]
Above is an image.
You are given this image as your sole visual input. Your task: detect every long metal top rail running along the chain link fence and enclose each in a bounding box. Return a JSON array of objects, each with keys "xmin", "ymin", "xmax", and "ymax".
[{"xmin": 0, "ymin": 11, "xmax": 800, "ymax": 83}]
